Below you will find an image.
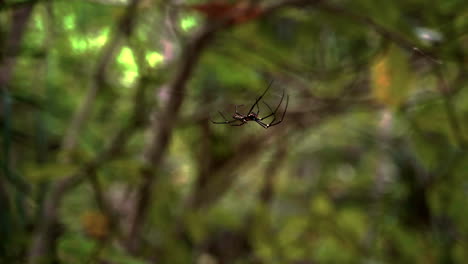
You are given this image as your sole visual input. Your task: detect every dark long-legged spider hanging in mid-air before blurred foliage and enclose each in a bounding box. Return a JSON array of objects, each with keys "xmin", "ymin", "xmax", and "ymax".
[{"xmin": 211, "ymin": 82, "xmax": 289, "ymax": 129}]
